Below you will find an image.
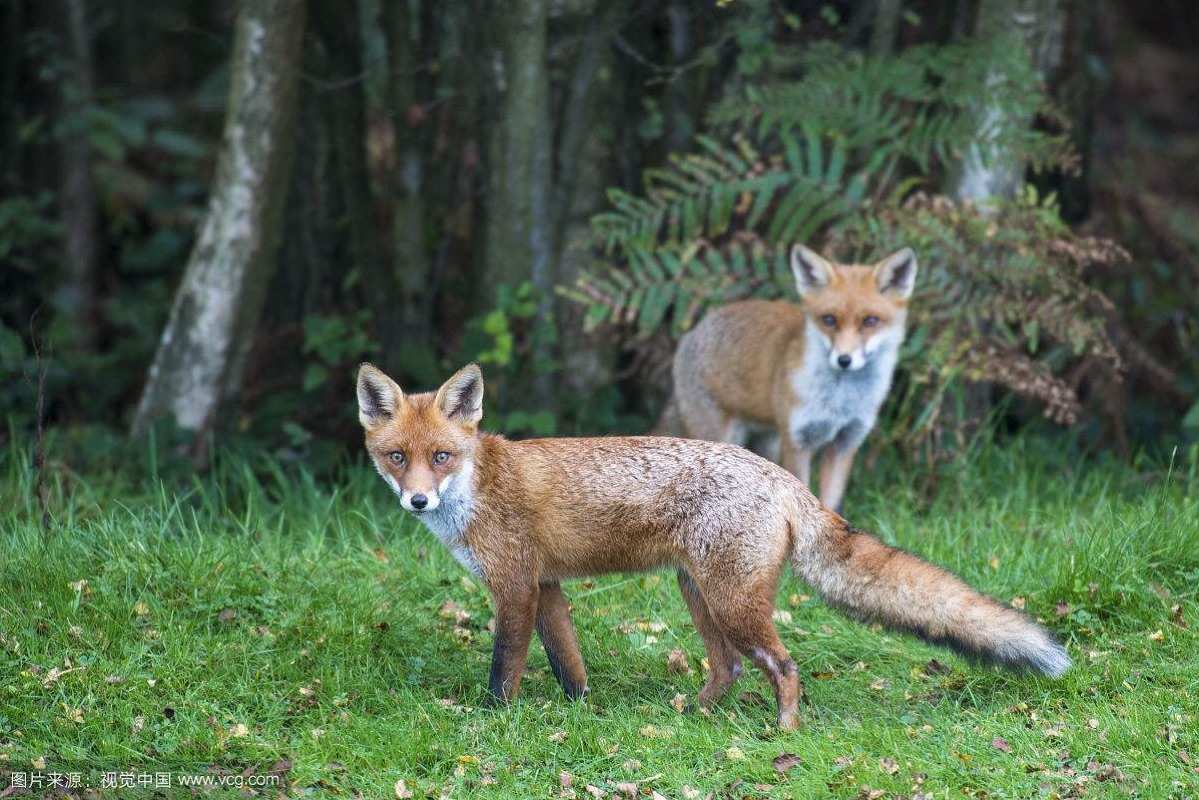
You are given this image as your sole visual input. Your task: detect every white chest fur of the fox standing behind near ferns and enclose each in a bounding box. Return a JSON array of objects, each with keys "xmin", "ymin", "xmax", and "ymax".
[{"xmin": 788, "ymin": 327, "xmax": 903, "ymax": 450}]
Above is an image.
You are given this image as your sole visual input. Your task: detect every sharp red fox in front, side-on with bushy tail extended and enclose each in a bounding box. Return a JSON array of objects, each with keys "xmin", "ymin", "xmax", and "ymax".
[{"xmin": 357, "ymin": 365, "xmax": 1071, "ymax": 728}]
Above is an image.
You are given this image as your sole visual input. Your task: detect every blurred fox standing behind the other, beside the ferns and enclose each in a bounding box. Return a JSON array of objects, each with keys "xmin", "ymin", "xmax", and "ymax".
[{"xmin": 656, "ymin": 245, "xmax": 916, "ymax": 511}]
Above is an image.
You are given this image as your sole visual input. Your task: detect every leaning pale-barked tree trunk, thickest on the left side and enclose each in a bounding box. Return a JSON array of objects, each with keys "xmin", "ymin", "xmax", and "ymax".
[{"xmin": 133, "ymin": 0, "xmax": 305, "ymax": 441}]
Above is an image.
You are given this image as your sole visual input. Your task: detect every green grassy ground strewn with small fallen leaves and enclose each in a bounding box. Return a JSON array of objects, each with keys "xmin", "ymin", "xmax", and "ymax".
[{"xmin": 0, "ymin": 441, "xmax": 1199, "ymax": 798}]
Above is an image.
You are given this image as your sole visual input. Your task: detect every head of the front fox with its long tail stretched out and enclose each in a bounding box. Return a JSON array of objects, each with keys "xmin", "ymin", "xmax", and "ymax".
[{"xmin": 359, "ymin": 363, "xmax": 483, "ymax": 515}]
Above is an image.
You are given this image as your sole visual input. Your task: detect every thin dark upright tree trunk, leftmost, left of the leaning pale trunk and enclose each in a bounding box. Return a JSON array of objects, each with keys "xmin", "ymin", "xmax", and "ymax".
[{"xmin": 58, "ymin": 0, "xmax": 97, "ymax": 350}]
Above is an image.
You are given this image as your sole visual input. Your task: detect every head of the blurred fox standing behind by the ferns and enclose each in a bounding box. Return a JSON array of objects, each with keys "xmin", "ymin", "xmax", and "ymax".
[{"xmin": 791, "ymin": 245, "xmax": 916, "ymax": 372}]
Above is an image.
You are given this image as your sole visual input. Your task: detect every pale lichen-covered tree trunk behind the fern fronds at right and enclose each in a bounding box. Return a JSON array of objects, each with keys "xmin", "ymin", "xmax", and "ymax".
[{"xmin": 952, "ymin": 0, "xmax": 1062, "ymax": 201}]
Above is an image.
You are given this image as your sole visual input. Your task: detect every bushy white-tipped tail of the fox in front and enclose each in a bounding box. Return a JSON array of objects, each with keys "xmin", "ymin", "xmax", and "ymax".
[{"xmin": 793, "ymin": 513, "xmax": 1071, "ymax": 678}]
